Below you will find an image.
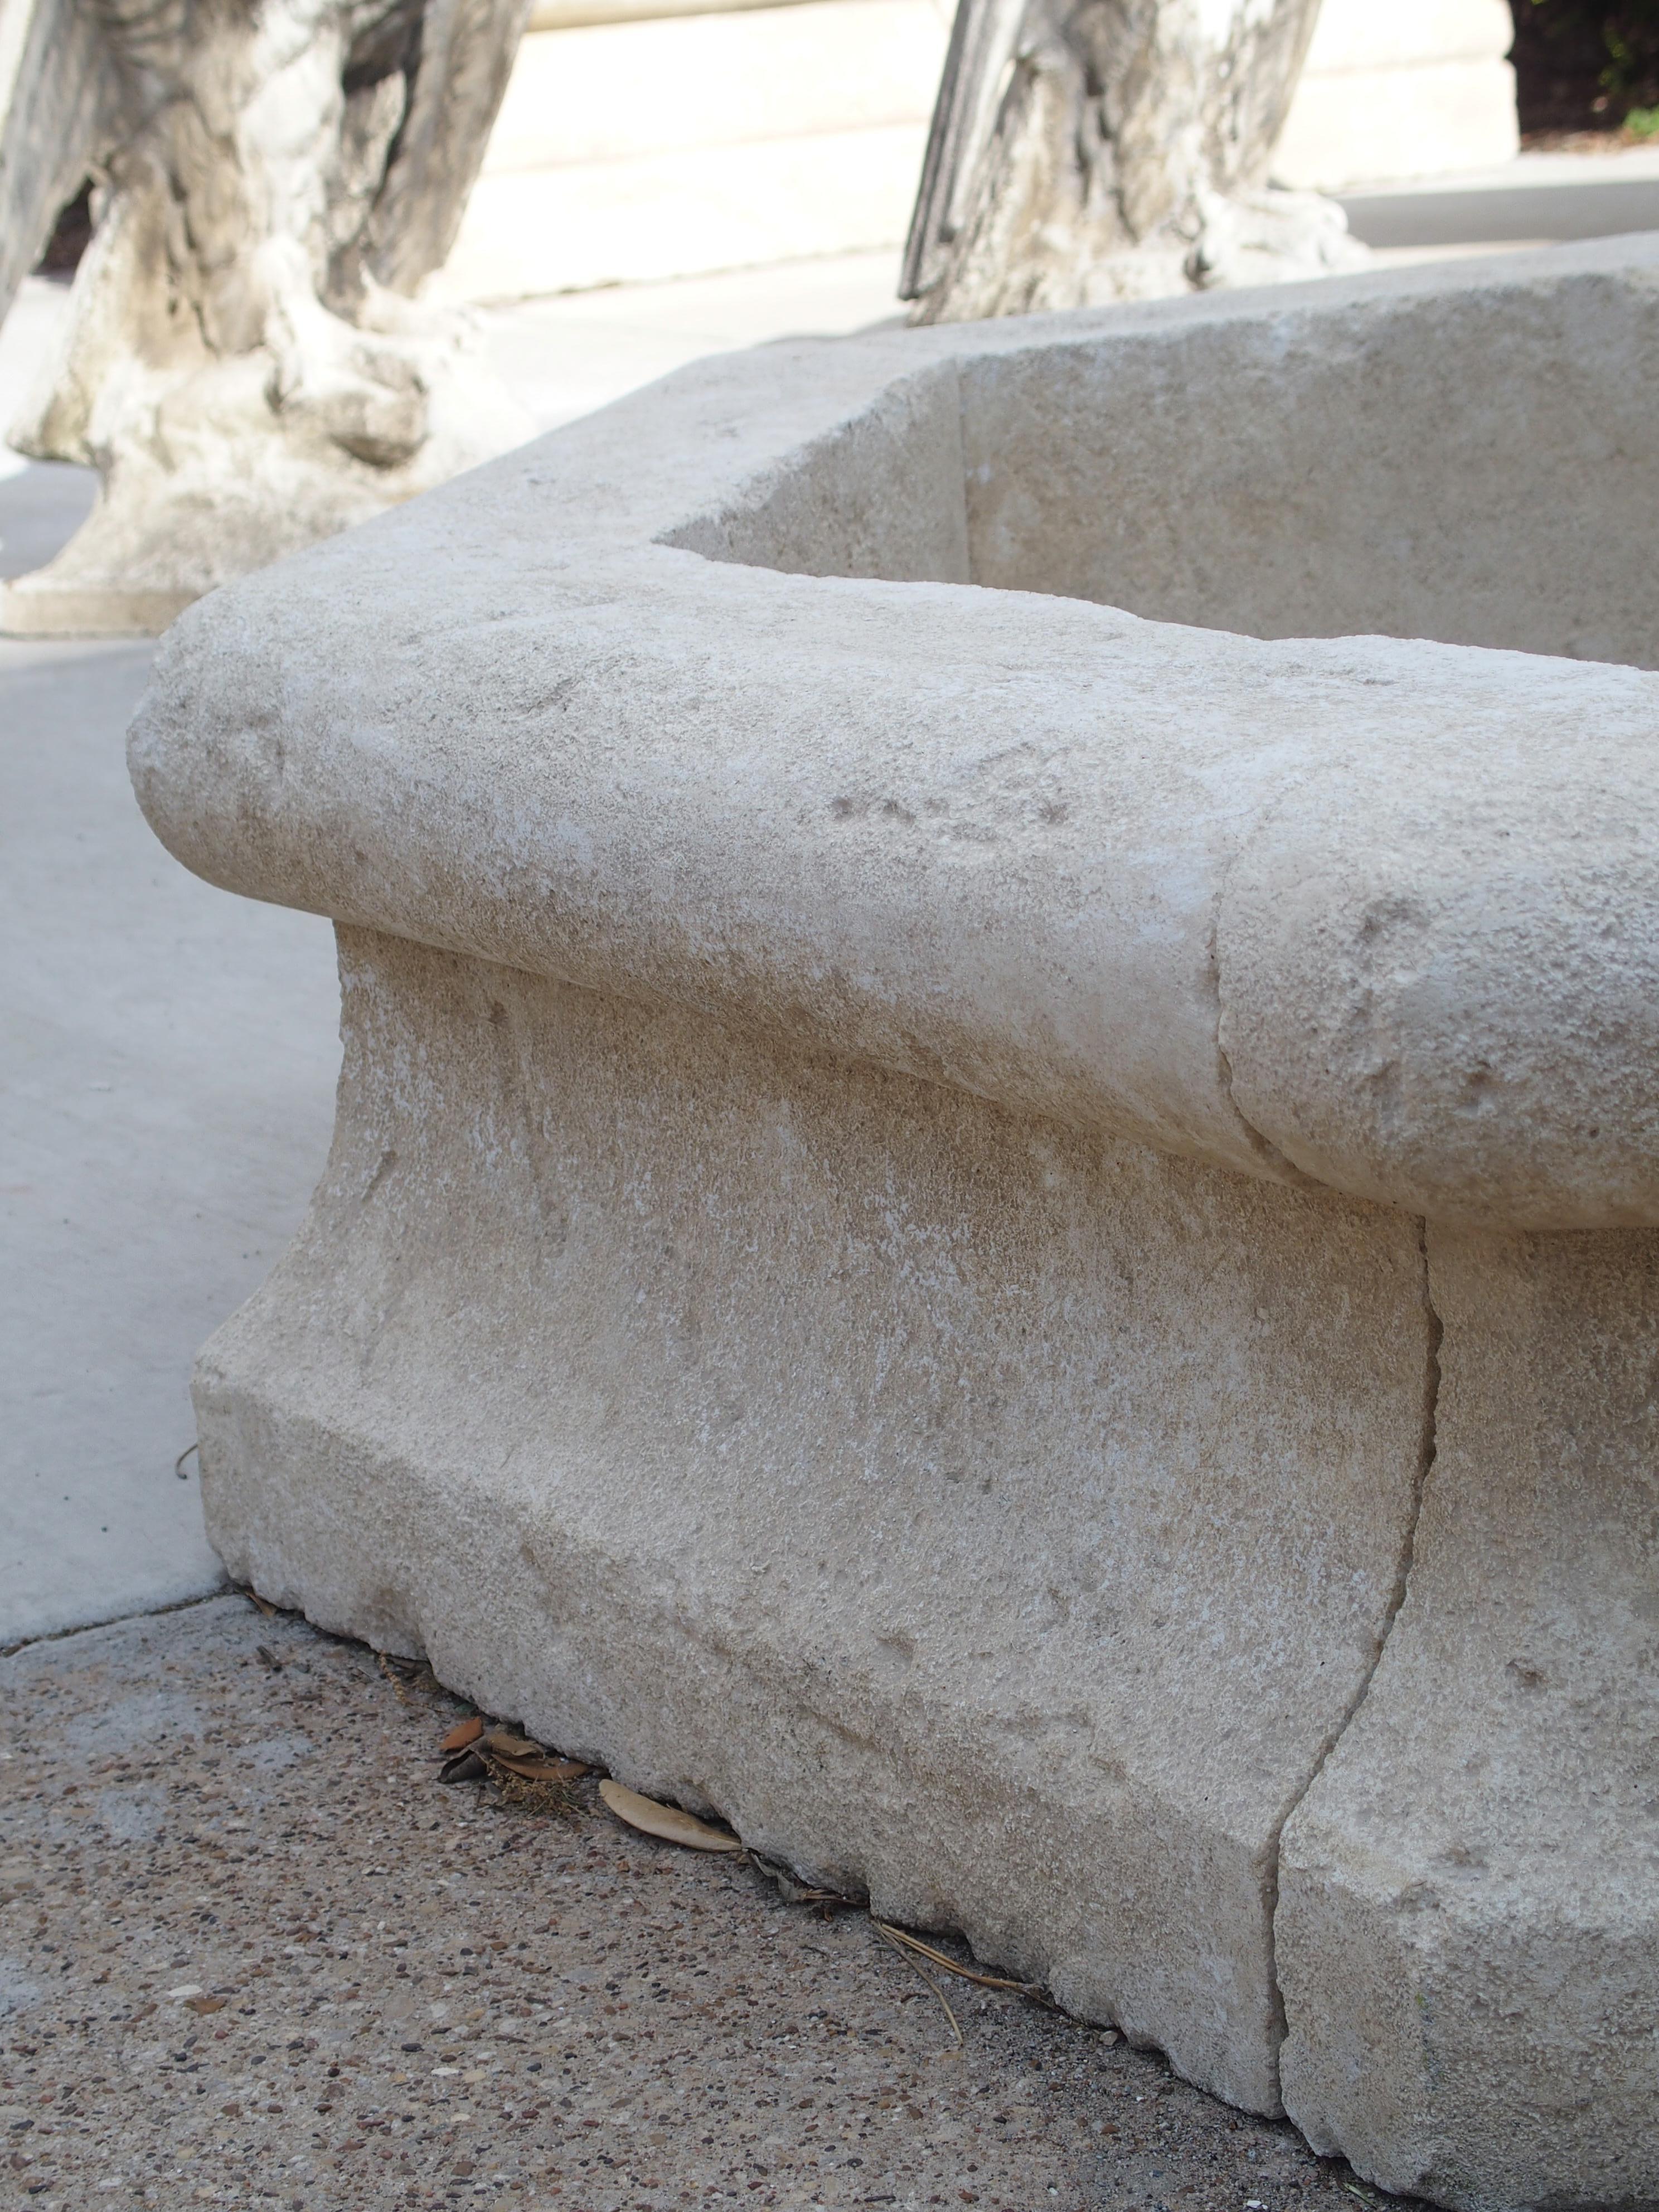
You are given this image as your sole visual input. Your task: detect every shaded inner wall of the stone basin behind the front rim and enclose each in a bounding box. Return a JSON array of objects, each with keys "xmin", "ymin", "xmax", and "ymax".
[{"xmin": 668, "ymin": 272, "xmax": 1659, "ymax": 668}]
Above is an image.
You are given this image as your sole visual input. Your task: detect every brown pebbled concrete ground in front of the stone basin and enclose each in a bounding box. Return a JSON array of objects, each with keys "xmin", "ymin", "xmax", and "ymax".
[{"xmin": 0, "ymin": 1601, "xmax": 1415, "ymax": 2212}]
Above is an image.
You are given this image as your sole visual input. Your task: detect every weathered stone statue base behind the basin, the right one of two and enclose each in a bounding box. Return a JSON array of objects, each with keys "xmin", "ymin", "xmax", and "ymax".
[{"xmin": 900, "ymin": 0, "xmax": 1367, "ymax": 323}]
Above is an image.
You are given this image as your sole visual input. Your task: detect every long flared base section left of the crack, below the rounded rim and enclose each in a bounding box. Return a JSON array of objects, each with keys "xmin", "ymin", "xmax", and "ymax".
[{"xmin": 197, "ymin": 933, "xmax": 1433, "ymax": 2110}]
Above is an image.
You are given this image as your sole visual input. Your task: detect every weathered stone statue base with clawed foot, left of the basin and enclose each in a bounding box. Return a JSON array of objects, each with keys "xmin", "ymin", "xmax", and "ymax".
[{"xmin": 0, "ymin": 0, "xmax": 531, "ymax": 633}]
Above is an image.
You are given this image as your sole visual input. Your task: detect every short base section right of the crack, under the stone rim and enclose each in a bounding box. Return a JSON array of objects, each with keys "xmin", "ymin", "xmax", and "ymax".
[{"xmin": 1277, "ymin": 1230, "xmax": 1659, "ymax": 2205}]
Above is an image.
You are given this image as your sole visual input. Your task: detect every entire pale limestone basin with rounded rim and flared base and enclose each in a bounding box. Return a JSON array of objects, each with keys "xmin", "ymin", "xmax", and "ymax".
[{"xmin": 130, "ymin": 241, "xmax": 1659, "ymax": 2212}]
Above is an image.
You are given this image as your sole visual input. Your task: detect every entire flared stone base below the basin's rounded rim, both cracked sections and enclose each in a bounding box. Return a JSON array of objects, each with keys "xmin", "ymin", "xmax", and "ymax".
[{"xmin": 197, "ymin": 933, "xmax": 1659, "ymax": 2205}]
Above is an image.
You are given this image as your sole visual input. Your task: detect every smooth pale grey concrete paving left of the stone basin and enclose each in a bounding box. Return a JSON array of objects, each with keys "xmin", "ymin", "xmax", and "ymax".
[{"xmin": 0, "ymin": 619, "xmax": 338, "ymax": 1643}]
